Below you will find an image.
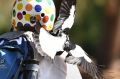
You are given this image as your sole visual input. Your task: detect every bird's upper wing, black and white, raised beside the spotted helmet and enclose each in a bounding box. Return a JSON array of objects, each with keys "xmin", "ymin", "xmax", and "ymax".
[{"xmin": 53, "ymin": 0, "xmax": 76, "ymax": 33}]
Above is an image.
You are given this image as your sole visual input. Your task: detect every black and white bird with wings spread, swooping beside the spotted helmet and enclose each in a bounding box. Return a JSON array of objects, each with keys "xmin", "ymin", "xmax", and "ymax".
[{"xmin": 39, "ymin": 0, "xmax": 103, "ymax": 79}]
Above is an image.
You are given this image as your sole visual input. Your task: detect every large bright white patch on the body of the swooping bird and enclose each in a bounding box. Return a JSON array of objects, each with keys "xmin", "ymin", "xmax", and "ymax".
[{"xmin": 39, "ymin": 28, "xmax": 66, "ymax": 58}]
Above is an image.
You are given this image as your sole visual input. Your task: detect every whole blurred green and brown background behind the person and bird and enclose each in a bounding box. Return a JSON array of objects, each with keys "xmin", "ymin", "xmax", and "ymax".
[{"xmin": 0, "ymin": 0, "xmax": 120, "ymax": 79}]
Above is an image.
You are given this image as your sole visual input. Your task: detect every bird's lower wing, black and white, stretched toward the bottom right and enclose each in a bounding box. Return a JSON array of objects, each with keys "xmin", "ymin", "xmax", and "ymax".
[{"xmin": 66, "ymin": 45, "xmax": 103, "ymax": 79}]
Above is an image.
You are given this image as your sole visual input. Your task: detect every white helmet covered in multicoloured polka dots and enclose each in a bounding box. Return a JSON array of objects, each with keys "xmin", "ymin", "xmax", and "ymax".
[{"xmin": 12, "ymin": 0, "xmax": 55, "ymax": 31}]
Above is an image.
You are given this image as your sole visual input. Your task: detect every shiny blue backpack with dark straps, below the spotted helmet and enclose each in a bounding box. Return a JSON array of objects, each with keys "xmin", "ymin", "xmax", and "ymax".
[{"xmin": 0, "ymin": 32, "xmax": 39, "ymax": 79}]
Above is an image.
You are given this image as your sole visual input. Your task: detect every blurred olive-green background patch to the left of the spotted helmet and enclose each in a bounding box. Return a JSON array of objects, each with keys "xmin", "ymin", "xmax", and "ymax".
[{"xmin": 0, "ymin": 0, "xmax": 13, "ymax": 34}]
